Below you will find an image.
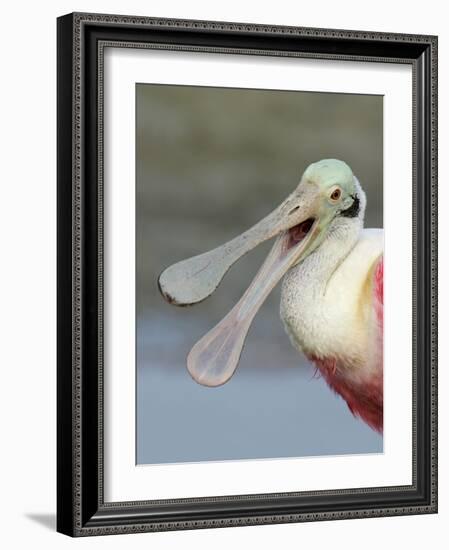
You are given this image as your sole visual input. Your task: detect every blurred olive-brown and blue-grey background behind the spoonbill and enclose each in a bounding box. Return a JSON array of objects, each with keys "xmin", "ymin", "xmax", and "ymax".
[{"xmin": 136, "ymin": 84, "xmax": 383, "ymax": 464}]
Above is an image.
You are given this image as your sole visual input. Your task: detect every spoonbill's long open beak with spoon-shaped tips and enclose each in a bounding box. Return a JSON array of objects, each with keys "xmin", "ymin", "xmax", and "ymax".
[{"xmin": 159, "ymin": 182, "xmax": 324, "ymax": 386}]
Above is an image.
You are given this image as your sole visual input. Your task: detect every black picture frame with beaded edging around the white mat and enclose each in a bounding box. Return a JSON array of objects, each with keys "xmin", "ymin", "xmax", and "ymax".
[{"xmin": 57, "ymin": 13, "xmax": 437, "ymax": 536}]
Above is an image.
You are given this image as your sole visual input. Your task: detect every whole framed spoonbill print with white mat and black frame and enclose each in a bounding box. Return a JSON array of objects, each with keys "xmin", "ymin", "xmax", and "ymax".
[{"xmin": 57, "ymin": 13, "xmax": 437, "ymax": 536}]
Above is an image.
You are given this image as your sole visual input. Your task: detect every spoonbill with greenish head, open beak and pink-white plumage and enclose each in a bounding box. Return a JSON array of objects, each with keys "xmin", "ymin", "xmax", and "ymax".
[{"xmin": 158, "ymin": 159, "xmax": 384, "ymax": 433}]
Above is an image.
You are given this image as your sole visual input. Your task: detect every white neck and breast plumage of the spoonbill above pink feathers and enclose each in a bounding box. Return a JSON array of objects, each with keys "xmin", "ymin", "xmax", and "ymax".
[{"xmin": 280, "ymin": 229, "xmax": 383, "ymax": 378}]
